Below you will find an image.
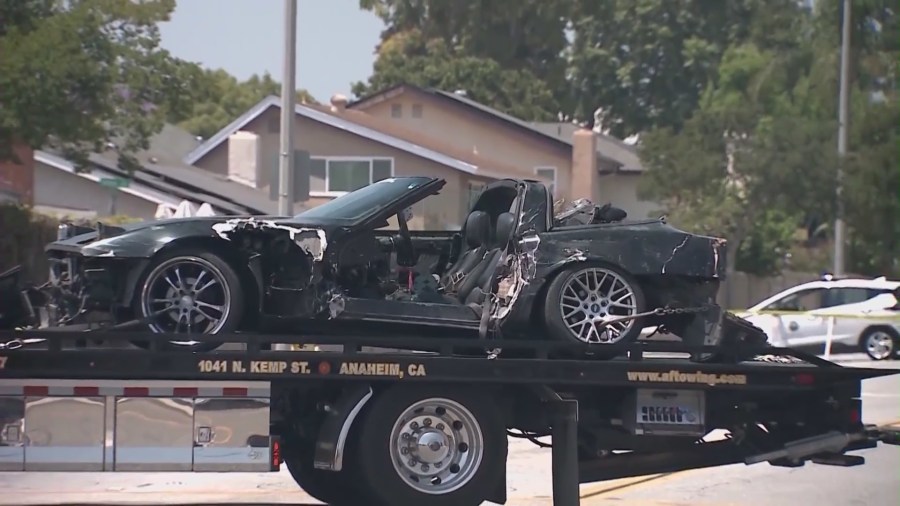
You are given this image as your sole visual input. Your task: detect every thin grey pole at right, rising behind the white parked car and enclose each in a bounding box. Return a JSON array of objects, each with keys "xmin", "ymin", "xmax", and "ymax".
[{"xmin": 834, "ymin": 0, "xmax": 850, "ymax": 276}]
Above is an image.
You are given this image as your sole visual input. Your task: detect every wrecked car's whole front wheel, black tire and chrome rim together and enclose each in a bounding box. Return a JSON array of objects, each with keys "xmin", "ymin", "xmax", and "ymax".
[{"xmin": 133, "ymin": 248, "xmax": 245, "ymax": 352}]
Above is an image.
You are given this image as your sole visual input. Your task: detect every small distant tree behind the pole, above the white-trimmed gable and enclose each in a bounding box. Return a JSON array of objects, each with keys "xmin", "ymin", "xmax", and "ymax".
[{"xmin": 174, "ymin": 69, "xmax": 316, "ymax": 138}]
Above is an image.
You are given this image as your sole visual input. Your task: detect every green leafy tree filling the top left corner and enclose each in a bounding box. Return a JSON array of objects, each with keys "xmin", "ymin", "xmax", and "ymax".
[{"xmin": 0, "ymin": 0, "xmax": 200, "ymax": 170}]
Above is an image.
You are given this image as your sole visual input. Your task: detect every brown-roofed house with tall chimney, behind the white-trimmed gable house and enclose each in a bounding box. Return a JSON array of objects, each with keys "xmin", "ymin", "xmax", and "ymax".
[{"xmin": 347, "ymin": 84, "xmax": 659, "ymax": 218}]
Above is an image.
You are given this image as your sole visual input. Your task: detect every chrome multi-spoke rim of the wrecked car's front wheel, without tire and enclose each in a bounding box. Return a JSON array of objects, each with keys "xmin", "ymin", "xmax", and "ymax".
[{"xmin": 141, "ymin": 256, "xmax": 232, "ymax": 345}]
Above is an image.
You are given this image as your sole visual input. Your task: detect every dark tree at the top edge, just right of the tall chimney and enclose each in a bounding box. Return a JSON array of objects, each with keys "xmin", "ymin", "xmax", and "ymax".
[{"xmin": 569, "ymin": 0, "xmax": 803, "ymax": 137}]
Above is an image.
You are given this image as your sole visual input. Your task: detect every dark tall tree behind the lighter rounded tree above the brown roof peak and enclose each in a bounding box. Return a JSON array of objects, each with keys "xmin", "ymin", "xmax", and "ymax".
[{"xmin": 360, "ymin": 0, "xmax": 572, "ymax": 106}]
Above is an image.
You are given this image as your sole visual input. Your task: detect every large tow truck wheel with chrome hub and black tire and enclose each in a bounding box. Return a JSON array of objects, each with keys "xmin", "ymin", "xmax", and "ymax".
[{"xmin": 359, "ymin": 385, "xmax": 507, "ymax": 506}]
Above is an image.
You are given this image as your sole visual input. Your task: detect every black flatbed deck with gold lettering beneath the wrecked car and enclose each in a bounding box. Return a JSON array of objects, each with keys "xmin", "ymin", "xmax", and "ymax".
[{"xmin": 0, "ymin": 330, "xmax": 884, "ymax": 390}]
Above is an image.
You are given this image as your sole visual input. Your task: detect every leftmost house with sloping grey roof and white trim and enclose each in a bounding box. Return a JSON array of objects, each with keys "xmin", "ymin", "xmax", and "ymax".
[{"xmin": 33, "ymin": 125, "xmax": 277, "ymax": 219}]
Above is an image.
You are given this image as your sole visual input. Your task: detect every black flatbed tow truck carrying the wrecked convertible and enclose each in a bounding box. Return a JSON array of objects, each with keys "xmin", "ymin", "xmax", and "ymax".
[{"xmin": 0, "ymin": 329, "xmax": 900, "ymax": 506}]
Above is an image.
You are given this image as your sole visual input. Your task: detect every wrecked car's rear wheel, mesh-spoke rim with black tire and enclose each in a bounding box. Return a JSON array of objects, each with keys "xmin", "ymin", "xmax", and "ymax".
[{"xmin": 544, "ymin": 264, "xmax": 646, "ymax": 346}]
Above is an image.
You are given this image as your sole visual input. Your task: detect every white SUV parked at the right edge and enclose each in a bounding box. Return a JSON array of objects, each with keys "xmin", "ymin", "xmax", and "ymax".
[{"xmin": 738, "ymin": 277, "xmax": 900, "ymax": 360}]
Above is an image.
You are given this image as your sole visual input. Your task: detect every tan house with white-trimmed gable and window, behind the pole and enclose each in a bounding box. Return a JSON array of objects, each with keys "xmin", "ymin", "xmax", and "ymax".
[{"xmin": 183, "ymin": 95, "xmax": 552, "ymax": 229}]
